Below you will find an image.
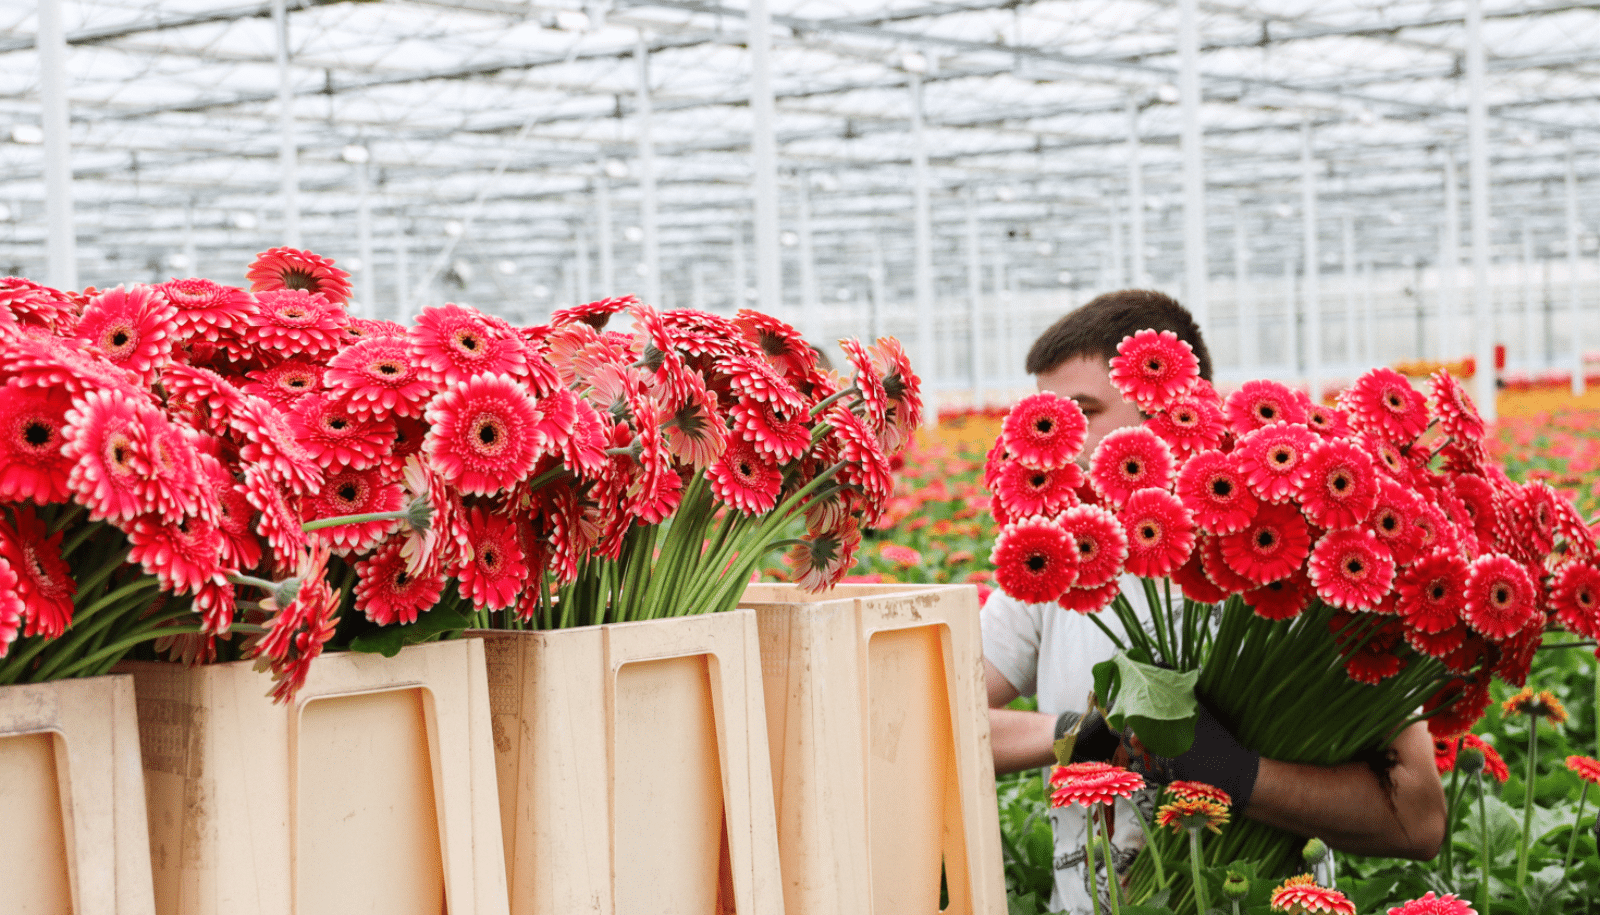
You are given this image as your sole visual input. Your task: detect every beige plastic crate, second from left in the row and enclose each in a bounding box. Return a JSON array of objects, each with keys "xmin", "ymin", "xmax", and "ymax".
[{"xmin": 125, "ymin": 640, "xmax": 507, "ymax": 915}]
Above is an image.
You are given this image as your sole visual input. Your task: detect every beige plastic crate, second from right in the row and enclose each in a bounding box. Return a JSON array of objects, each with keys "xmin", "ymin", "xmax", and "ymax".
[{"xmin": 474, "ymin": 611, "xmax": 782, "ymax": 915}]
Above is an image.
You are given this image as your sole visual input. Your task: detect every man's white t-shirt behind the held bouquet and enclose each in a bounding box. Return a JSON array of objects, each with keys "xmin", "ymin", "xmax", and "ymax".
[{"xmin": 981, "ymin": 576, "xmax": 1155, "ymax": 915}]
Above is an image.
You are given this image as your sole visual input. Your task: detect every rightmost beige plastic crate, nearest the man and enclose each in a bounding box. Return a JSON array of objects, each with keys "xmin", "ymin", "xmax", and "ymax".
[{"xmin": 742, "ymin": 585, "xmax": 1006, "ymax": 915}]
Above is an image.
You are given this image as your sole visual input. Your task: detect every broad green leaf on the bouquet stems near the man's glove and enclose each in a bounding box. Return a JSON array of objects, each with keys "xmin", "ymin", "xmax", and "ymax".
[{"xmin": 1094, "ymin": 651, "xmax": 1200, "ymax": 757}]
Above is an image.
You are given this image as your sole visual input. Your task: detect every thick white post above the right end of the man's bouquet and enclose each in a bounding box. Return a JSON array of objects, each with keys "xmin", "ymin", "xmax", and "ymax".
[{"xmin": 1466, "ymin": 0, "xmax": 1498, "ymax": 422}]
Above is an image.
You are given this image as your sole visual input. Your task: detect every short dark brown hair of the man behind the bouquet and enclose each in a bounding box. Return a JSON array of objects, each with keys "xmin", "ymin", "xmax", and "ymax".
[{"xmin": 1027, "ymin": 290, "xmax": 1211, "ymax": 381}]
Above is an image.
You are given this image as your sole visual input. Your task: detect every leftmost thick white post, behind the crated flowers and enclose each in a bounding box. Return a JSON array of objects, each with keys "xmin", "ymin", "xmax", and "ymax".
[{"xmin": 37, "ymin": 0, "xmax": 78, "ymax": 290}]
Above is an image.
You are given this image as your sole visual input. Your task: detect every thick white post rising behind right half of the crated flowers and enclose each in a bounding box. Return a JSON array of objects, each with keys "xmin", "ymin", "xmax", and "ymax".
[{"xmin": 747, "ymin": 0, "xmax": 784, "ymax": 315}]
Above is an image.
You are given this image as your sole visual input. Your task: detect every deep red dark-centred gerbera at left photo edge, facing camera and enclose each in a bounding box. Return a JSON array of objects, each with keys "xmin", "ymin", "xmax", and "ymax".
[{"xmin": 0, "ymin": 381, "xmax": 74, "ymax": 505}]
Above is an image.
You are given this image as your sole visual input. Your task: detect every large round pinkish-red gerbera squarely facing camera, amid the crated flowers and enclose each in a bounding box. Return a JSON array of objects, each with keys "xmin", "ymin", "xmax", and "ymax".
[{"xmin": 422, "ymin": 374, "xmax": 544, "ymax": 494}]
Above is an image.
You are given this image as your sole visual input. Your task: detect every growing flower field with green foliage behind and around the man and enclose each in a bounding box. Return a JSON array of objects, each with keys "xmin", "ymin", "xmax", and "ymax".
[{"xmin": 768, "ymin": 401, "xmax": 1600, "ymax": 915}]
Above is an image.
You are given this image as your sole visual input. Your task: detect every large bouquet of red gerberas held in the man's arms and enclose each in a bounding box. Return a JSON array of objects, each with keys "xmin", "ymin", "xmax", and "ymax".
[{"xmin": 987, "ymin": 331, "xmax": 1600, "ymax": 905}]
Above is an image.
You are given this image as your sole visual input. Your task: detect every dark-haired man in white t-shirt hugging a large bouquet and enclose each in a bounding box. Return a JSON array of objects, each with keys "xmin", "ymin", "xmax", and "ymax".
[{"xmin": 982, "ymin": 290, "xmax": 1445, "ymax": 912}]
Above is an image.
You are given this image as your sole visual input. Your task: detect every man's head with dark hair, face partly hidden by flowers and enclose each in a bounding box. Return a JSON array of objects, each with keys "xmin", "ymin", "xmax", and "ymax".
[{"xmin": 1027, "ymin": 290, "xmax": 1211, "ymax": 458}]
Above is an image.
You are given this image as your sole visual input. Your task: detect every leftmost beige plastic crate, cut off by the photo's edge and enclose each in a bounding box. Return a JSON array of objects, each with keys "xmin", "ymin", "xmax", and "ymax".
[{"xmin": 0, "ymin": 677, "xmax": 155, "ymax": 915}]
